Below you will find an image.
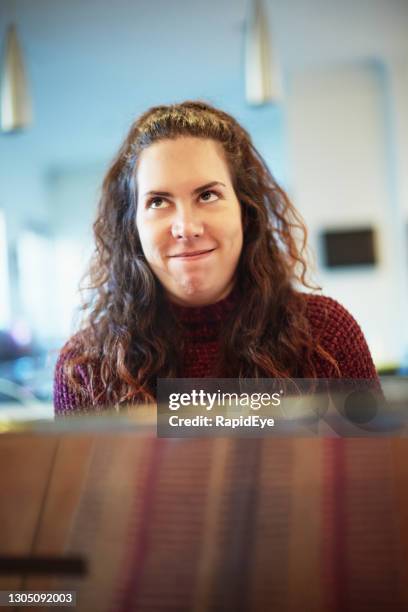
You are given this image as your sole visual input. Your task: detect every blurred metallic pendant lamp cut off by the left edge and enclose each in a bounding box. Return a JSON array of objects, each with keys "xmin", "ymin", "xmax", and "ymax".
[{"xmin": 0, "ymin": 25, "xmax": 32, "ymax": 132}]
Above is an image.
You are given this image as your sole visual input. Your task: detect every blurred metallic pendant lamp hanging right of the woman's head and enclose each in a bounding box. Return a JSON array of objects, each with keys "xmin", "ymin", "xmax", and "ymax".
[{"xmin": 245, "ymin": 0, "xmax": 282, "ymax": 105}]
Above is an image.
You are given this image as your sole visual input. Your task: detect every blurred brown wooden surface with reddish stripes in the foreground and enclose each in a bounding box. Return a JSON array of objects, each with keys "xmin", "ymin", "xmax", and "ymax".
[{"xmin": 0, "ymin": 433, "xmax": 408, "ymax": 612}]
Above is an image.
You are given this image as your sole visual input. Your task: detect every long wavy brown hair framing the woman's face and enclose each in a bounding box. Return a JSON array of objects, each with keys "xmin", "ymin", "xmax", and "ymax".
[{"xmin": 63, "ymin": 101, "xmax": 337, "ymax": 405}]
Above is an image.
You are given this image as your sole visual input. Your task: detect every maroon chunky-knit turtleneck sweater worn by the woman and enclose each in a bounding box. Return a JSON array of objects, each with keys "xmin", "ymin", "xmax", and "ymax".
[{"xmin": 54, "ymin": 294, "xmax": 377, "ymax": 413}]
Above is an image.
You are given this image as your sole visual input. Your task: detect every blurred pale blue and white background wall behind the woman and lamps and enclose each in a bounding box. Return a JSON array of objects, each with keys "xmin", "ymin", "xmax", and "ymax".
[{"xmin": 0, "ymin": 0, "xmax": 408, "ymax": 396}]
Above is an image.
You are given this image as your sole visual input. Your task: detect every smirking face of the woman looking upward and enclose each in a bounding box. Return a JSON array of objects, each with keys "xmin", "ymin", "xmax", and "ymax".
[{"xmin": 136, "ymin": 137, "xmax": 243, "ymax": 306}]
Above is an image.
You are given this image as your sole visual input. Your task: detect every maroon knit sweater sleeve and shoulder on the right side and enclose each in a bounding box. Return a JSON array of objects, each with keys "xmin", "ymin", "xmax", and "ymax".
[{"xmin": 307, "ymin": 295, "xmax": 378, "ymax": 380}]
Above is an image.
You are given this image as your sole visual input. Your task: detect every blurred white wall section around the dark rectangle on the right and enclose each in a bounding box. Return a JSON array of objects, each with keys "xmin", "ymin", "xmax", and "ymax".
[{"xmin": 288, "ymin": 62, "xmax": 408, "ymax": 364}]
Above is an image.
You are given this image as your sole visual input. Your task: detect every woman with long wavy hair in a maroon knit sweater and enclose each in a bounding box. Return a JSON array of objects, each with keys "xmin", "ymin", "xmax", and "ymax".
[{"xmin": 54, "ymin": 102, "xmax": 376, "ymax": 412}]
